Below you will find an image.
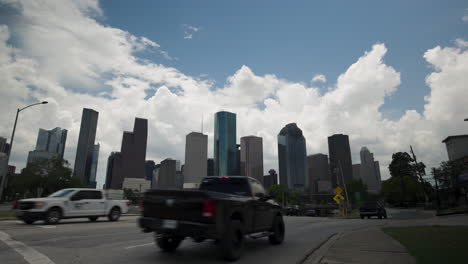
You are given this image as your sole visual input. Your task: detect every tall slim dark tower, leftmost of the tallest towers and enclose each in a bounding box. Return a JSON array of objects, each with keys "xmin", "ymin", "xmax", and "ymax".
[{"xmin": 73, "ymin": 108, "xmax": 99, "ymax": 185}]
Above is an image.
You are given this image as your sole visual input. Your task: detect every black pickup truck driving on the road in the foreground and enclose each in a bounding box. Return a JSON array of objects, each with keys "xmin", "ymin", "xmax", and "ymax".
[{"xmin": 138, "ymin": 176, "xmax": 285, "ymax": 260}]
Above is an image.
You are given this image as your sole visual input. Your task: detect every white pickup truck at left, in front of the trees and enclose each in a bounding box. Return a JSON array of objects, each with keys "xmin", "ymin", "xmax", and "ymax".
[{"xmin": 15, "ymin": 188, "xmax": 130, "ymax": 224}]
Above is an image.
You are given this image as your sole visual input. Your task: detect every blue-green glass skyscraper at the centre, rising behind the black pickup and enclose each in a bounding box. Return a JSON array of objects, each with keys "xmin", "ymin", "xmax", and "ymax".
[{"xmin": 214, "ymin": 111, "xmax": 239, "ymax": 176}]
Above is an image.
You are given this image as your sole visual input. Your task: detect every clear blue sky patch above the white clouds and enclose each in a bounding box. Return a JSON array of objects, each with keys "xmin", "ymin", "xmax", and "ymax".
[{"xmin": 98, "ymin": 0, "xmax": 468, "ymax": 119}]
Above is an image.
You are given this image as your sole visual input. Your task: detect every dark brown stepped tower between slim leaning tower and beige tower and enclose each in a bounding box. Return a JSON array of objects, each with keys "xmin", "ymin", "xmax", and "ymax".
[{"xmin": 105, "ymin": 118, "xmax": 148, "ymax": 189}]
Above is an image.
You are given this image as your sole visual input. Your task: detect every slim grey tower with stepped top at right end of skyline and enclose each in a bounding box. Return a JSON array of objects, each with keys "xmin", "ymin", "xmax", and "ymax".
[{"xmin": 360, "ymin": 147, "xmax": 380, "ymax": 193}]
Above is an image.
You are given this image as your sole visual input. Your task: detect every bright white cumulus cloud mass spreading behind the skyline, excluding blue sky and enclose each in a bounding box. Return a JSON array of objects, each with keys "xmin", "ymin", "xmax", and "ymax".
[{"xmin": 0, "ymin": 0, "xmax": 468, "ymax": 186}]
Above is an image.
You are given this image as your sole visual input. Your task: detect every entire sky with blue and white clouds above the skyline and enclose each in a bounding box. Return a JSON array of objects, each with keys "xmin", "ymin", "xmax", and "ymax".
[{"xmin": 0, "ymin": 0, "xmax": 468, "ymax": 189}]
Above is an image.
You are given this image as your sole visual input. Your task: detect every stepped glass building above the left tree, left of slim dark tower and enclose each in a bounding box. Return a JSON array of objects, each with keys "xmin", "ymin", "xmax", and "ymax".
[{"xmin": 28, "ymin": 127, "xmax": 67, "ymax": 163}]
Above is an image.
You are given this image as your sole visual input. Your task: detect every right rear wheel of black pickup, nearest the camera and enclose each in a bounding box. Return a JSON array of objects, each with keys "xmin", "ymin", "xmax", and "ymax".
[{"xmin": 221, "ymin": 220, "xmax": 244, "ymax": 261}]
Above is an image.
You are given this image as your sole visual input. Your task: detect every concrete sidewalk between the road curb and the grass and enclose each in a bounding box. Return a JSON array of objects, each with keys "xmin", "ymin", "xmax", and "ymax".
[{"xmin": 303, "ymin": 227, "xmax": 416, "ymax": 264}]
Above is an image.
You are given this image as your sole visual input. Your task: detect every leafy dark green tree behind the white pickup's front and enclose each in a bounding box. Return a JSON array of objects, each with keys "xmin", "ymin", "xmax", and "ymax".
[{"xmin": 8, "ymin": 158, "xmax": 83, "ymax": 197}]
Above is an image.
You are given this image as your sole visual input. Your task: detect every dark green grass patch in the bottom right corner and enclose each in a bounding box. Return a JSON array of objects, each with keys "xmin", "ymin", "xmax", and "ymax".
[{"xmin": 382, "ymin": 226, "xmax": 468, "ymax": 264}]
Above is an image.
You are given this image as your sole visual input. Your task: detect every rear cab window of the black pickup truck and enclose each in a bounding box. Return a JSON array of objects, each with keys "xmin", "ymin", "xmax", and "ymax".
[{"xmin": 200, "ymin": 178, "xmax": 250, "ymax": 196}]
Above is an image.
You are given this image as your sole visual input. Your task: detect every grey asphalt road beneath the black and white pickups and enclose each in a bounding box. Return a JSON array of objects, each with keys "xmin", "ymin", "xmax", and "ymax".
[{"xmin": 0, "ymin": 210, "xmax": 436, "ymax": 264}]
